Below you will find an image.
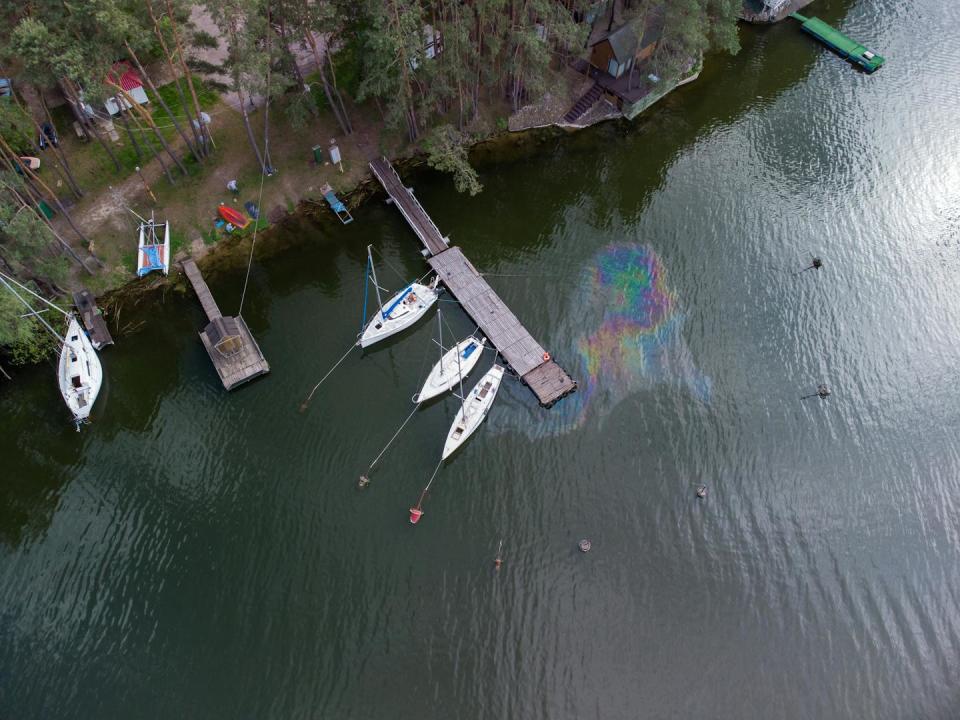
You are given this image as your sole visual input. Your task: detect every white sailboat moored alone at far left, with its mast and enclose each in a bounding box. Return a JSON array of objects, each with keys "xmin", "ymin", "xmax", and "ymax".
[{"xmin": 0, "ymin": 273, "xmax": 103, "ymax": 430}]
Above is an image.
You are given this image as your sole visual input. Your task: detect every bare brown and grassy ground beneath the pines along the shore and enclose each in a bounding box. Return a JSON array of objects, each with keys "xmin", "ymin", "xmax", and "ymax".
[{"xmin": 51, "ymin": 88, "xmax": 403, "ymax": 293}]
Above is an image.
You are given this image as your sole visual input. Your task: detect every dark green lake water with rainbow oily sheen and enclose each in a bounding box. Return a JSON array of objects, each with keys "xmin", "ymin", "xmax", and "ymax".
[{"xmin": 0, "ymin": 0, "xmax": 960, "ymax": 720}]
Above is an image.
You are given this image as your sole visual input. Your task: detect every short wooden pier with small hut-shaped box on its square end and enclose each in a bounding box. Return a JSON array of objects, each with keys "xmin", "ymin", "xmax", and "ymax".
[{"xmin": 182, "ymin": 260, "xmax": 270, "ymax": 390}]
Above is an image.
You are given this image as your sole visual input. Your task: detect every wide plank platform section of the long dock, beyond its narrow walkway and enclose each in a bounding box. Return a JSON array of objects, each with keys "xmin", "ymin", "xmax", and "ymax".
[{"xmin": 428, "ymin": 247, "xmax": 577, "ymax": 407}]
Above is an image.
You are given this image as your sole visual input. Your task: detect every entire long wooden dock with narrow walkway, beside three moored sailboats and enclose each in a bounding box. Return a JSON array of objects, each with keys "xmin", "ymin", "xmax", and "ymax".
[{"xmin": 370, "ymin": 158, "xmax": 577, "ymax": 407}]
